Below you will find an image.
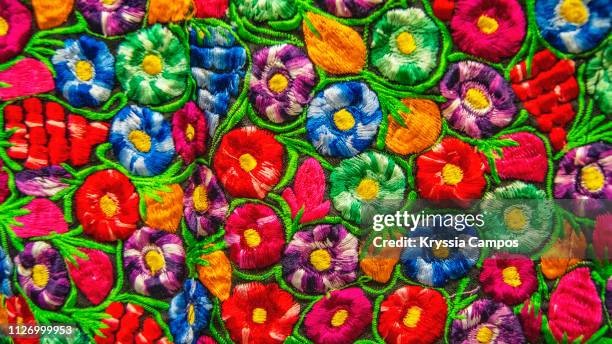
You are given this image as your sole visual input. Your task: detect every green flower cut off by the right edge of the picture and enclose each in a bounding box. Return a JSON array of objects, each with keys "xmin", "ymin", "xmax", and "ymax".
[{"xmin": 586, "ymin": 40, "xmax": 612, "ymax": 114}]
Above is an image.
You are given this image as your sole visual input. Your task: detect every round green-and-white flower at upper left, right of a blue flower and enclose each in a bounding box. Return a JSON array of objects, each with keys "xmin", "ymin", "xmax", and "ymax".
[{"xmin": 116, "ymin": 24, "xmax": 189, "ymax": 105}]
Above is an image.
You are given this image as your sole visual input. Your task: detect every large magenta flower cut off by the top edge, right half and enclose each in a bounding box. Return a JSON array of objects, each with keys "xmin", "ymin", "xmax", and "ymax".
[{"xmin": 451, "ymin": 0, "xmax": 527, "ymax": 62}]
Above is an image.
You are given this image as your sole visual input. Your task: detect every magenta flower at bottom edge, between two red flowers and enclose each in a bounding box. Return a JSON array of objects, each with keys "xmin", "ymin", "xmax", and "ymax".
[{"xmin": 304, "ymin": 288, "xmax": 372, "ymax": 344}]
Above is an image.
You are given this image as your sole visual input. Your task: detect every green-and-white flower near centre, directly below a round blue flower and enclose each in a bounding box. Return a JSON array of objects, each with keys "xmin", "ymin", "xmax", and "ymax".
[{"xmin": 330, "ymin": 152, "xmax": 406, "ymax": 223}]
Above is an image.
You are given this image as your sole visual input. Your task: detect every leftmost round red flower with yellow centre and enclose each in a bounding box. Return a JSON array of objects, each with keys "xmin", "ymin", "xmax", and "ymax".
[{"xmin": 75, "ymin": 170, "xmax": 140, "ymax": 241}]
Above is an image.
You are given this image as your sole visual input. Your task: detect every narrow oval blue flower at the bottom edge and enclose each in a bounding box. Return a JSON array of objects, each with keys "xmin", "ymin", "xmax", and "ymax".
[{"xmin": 168, "ymin": 279, "xmax": 213, "ymax": 344}]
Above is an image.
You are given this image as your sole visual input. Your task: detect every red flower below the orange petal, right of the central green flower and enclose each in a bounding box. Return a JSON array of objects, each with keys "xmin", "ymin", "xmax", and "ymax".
[{"xmin": 416, "ymin": 138, "xmax": 486, "ymax": 206}]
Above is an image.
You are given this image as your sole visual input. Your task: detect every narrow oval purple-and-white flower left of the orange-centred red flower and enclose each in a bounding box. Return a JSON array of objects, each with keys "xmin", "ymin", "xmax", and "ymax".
[{"xmin": 184, "ymin": 166, "xmax": 228, "ymax": 237}]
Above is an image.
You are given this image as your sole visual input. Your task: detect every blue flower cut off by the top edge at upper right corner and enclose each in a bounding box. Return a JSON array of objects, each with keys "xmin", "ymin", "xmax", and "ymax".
[{"xmin": 535, "ymin": 0, "xmax": 612, "ymax": 54}]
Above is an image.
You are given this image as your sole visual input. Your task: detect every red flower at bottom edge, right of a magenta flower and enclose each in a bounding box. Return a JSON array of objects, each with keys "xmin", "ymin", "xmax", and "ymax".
[{"xmin": 378, "ymin": 286, "xmax": 447, "ymax": 344}]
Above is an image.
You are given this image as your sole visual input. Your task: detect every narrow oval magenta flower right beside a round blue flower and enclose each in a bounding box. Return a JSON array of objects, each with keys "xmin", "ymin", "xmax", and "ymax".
[{"xmin": 172, "ymin": 102, "xmax": 208, "ymax": 164}]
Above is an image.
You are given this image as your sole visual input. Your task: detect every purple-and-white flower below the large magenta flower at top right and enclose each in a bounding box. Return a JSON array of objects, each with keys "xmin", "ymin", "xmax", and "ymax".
[{"xmin": 440, "ymin": 61, "xmax": 516, "ymax": 138}]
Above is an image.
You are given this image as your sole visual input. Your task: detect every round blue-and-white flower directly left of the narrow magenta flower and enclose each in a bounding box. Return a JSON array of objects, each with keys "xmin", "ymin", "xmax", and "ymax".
[{"xmin": 109, "ymin": 105, "xmax": 175, "ymax": 176}]
